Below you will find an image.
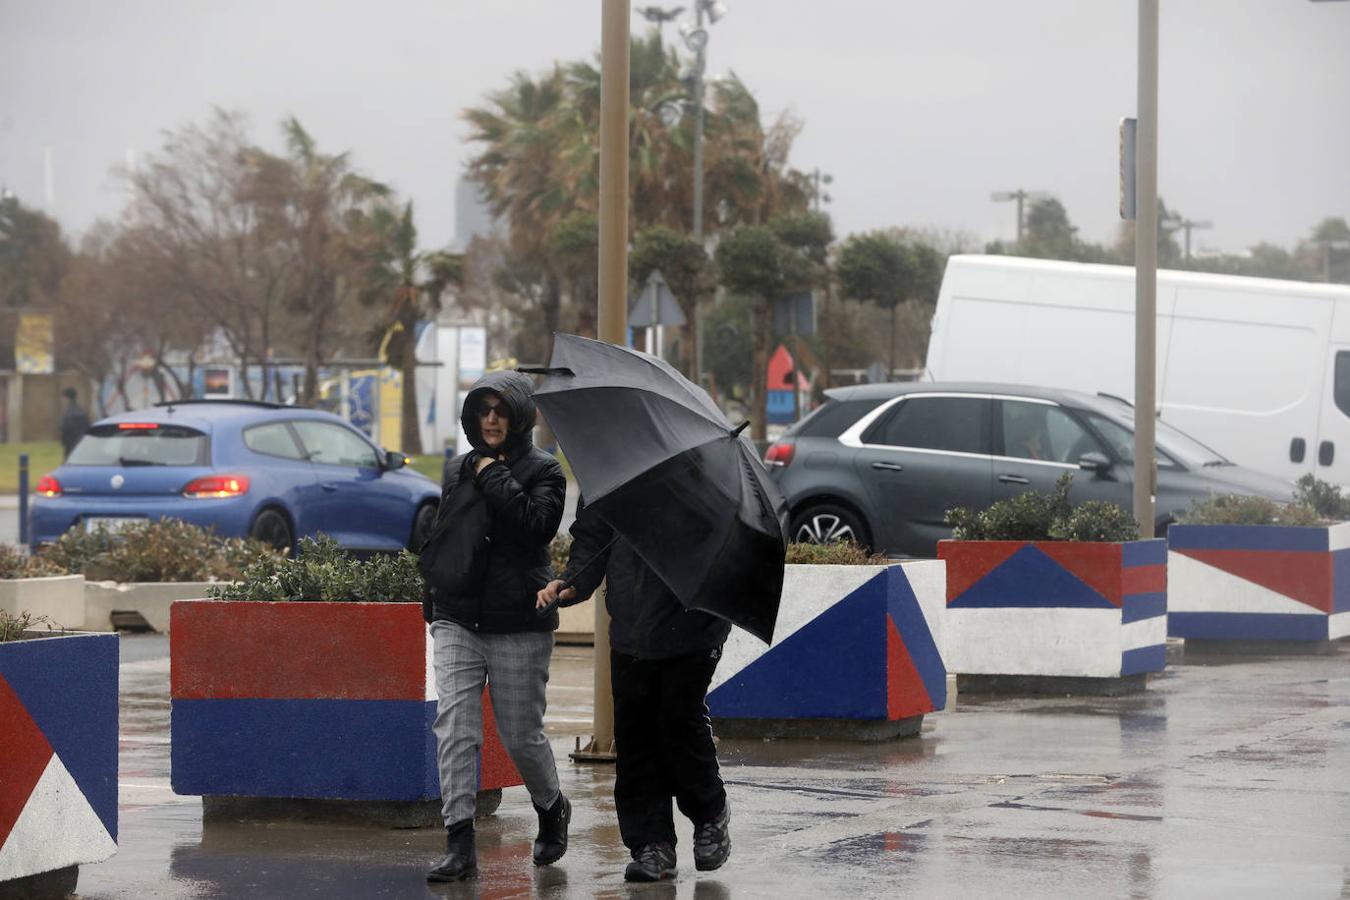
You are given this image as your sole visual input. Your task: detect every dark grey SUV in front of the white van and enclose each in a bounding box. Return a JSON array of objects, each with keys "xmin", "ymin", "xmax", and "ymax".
[{"xmin": 764, "ymin": 383, "xmax": 1293, "ymax": 556}]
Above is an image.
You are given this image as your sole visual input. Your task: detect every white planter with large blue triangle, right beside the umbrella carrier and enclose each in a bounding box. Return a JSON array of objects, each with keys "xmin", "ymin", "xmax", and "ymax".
[{"xmin": 707, "ymin": 560, "xmax": 946, "ymax": 739}]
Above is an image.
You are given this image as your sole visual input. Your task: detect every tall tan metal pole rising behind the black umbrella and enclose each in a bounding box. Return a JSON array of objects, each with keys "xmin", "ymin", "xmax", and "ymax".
[{"xmin": 572, "ymin": 0, "xmax": 629, "ymax": 762}]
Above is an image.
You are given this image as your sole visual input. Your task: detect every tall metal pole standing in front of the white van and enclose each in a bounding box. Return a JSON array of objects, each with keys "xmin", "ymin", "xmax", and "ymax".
[{"xmin": 1134, "ymin": 0, "xmax": 1158, "ymax": 537}]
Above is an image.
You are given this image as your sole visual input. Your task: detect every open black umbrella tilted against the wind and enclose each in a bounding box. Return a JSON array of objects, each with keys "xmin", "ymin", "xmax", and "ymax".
[{"xmin": 527, "ymin": 335, "xmax": 787, "ymax": 642}]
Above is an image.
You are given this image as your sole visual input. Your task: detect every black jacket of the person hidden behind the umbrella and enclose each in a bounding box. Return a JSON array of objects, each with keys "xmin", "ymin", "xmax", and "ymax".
[{"xmin": 562, "ymin": 503, "xmax": 732, "ymax": 660}]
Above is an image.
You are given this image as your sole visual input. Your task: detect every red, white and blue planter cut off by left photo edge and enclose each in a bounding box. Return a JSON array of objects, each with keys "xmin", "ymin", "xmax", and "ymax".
[{"xmin": 0, "ymin": 634, "xmax": 117, "ymax": 893}]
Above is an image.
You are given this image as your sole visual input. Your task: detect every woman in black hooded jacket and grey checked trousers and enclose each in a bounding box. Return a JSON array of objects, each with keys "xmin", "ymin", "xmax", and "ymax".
[{"xmin": 420, "ymin": 372, "xmax": 571, "ymax": 881}]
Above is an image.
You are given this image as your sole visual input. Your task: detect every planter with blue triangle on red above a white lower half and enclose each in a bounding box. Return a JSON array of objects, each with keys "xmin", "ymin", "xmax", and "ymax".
[{"xmin": 938, "ymin": 540, "xmax": 1168, "ymax": 677}]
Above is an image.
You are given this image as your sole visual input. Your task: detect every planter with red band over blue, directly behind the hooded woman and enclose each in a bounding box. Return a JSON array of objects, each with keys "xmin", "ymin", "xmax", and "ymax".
[{"xmin": 169, "ymin": 600, "xmax": 521, "ymax": 800}]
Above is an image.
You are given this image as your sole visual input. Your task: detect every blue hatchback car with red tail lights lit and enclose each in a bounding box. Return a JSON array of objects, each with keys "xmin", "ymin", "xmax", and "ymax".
[{"xmin": 31, "ymin": 401, "xmax": 440, "ymax": 552}]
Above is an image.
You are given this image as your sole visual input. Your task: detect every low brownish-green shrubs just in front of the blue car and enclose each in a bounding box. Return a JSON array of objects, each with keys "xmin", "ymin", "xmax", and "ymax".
[{"xmin": 39, "ymin": 518, "xmax": 275, "ymax": 582}]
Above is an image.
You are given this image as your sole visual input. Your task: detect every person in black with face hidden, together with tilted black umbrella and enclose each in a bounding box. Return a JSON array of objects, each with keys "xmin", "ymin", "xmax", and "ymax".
[{"xmin": 528, "ymin": 335, "xmax": 787, "ymax": 881}]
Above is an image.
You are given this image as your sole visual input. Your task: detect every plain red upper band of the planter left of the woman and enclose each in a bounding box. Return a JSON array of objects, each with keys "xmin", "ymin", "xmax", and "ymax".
[{"xmin": 169, "ymin": 600, "xmax": 427, "ymax": 702}]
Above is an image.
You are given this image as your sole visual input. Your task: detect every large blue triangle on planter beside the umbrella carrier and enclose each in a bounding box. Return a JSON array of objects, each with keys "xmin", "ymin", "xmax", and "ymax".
[{"xmin": 707, "ymin": 572, "xmax": 887, "ymax": 719}]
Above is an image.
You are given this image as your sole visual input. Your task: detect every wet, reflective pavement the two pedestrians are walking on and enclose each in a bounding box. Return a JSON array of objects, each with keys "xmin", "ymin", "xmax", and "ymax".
[{"xmin": 78, "ymin": 636, "xmax": 1350, "ymax": 900}]
